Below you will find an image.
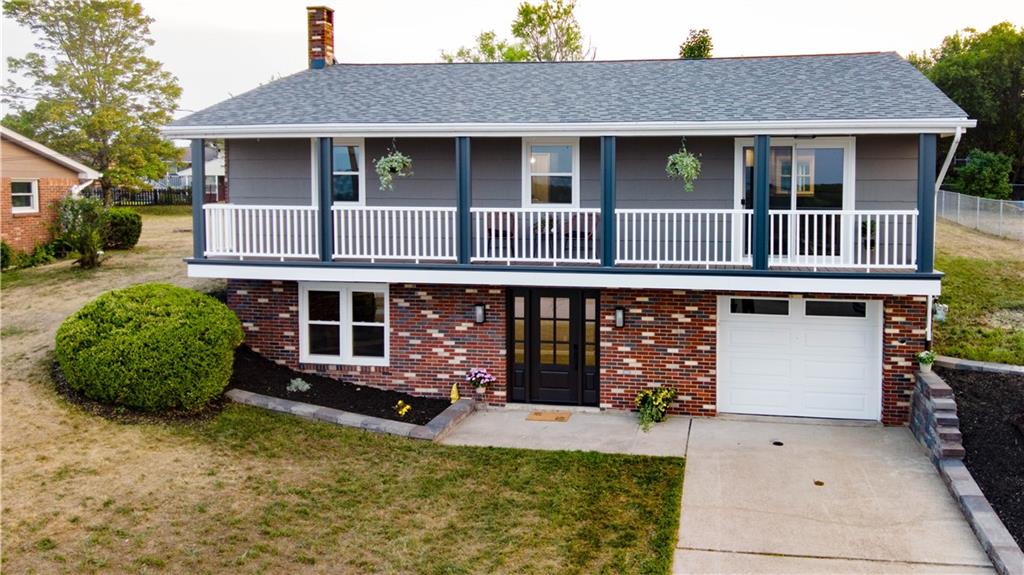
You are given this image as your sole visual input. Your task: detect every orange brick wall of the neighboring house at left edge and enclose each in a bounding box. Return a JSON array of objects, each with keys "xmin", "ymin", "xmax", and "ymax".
[{"xmin": 0, "ymin": 177, "xmax": 78, "ymax": 252}]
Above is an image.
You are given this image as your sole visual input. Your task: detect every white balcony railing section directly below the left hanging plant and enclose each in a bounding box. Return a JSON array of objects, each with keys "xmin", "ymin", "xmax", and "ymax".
[{"xmin": 331, "ymin": 206, "xmax": 458, "ymax": 263}]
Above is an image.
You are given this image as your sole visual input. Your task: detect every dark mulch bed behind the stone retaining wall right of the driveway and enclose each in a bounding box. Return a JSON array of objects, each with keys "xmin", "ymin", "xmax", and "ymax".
[{"xmin": 935, "ymin": 368, "xmax": 1024, "ymax": 547}]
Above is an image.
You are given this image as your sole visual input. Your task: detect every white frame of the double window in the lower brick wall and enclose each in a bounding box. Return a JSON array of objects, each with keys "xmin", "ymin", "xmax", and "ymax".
[{"xmin": 299, "ymin": 281, "xmax": 391, "ymax": 367}]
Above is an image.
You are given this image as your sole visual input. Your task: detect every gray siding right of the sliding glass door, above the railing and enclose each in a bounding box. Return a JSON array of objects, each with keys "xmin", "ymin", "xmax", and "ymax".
[{"xmin": 856, "ymin": 135, "xmax": 918, "ymax": 210}]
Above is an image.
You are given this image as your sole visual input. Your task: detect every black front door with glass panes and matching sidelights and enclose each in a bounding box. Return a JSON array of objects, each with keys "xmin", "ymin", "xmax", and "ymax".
[{"xmin": 509, "ymin": 289, "xmax": 598, "ymax": 405}]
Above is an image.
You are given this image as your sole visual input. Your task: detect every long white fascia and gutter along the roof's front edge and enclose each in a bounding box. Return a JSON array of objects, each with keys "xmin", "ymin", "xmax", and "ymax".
[{"xmin": 161, "ymin": 118, "xmax": 977, "ymax": 139}]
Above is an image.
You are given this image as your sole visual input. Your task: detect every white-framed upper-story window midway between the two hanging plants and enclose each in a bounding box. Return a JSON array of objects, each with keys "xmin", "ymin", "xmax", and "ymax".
[{"xmin": 522, "ymin": 138, "xmax": 580, "ymax": 208}]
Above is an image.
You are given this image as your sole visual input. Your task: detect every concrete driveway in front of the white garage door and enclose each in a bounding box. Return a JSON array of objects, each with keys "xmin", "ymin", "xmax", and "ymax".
[{"xmin": 673, "ymin": 417, "xmax": 993, "ymax": 573}]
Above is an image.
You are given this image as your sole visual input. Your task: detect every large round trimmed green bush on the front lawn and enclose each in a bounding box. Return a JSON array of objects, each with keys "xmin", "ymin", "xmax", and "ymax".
[{"xmin": 56, "ymin": 283, "xmax": 243, "ymax": 411}]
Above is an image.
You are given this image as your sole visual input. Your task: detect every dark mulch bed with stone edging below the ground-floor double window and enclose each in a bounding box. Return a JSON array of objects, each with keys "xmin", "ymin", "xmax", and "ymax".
[{"xmin": 228, "ymin": 346, "xmax": 451, "ymax": 426}]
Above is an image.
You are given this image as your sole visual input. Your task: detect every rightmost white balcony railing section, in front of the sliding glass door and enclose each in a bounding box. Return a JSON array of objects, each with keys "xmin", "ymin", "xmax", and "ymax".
[{"xmin": 770, "ymin": 210, "xmax": 918, "ymax": 270}]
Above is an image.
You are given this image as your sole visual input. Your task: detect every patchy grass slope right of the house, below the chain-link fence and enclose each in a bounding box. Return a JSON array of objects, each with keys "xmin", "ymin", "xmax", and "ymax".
[{"xmin": 934, "ymin": 224, "xmax": 1024, "ymax": 365}]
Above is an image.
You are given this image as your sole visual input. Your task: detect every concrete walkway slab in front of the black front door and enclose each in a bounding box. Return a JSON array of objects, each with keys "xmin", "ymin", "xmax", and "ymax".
[{"xmin": 441, "ymin": 407, "xmax": 690, "ymax": 457}]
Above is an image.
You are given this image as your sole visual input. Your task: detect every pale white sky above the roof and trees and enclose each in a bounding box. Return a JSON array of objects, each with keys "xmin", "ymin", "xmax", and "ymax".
[{"xmin": 2, "ymin": 0, "xmax": 1024, "ymax": 117}]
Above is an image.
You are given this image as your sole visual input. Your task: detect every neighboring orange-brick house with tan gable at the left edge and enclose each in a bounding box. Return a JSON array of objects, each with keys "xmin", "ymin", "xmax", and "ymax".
[{"xmin": 0, "ymin": 126, "xmax": 100, "ymax": 252}]
